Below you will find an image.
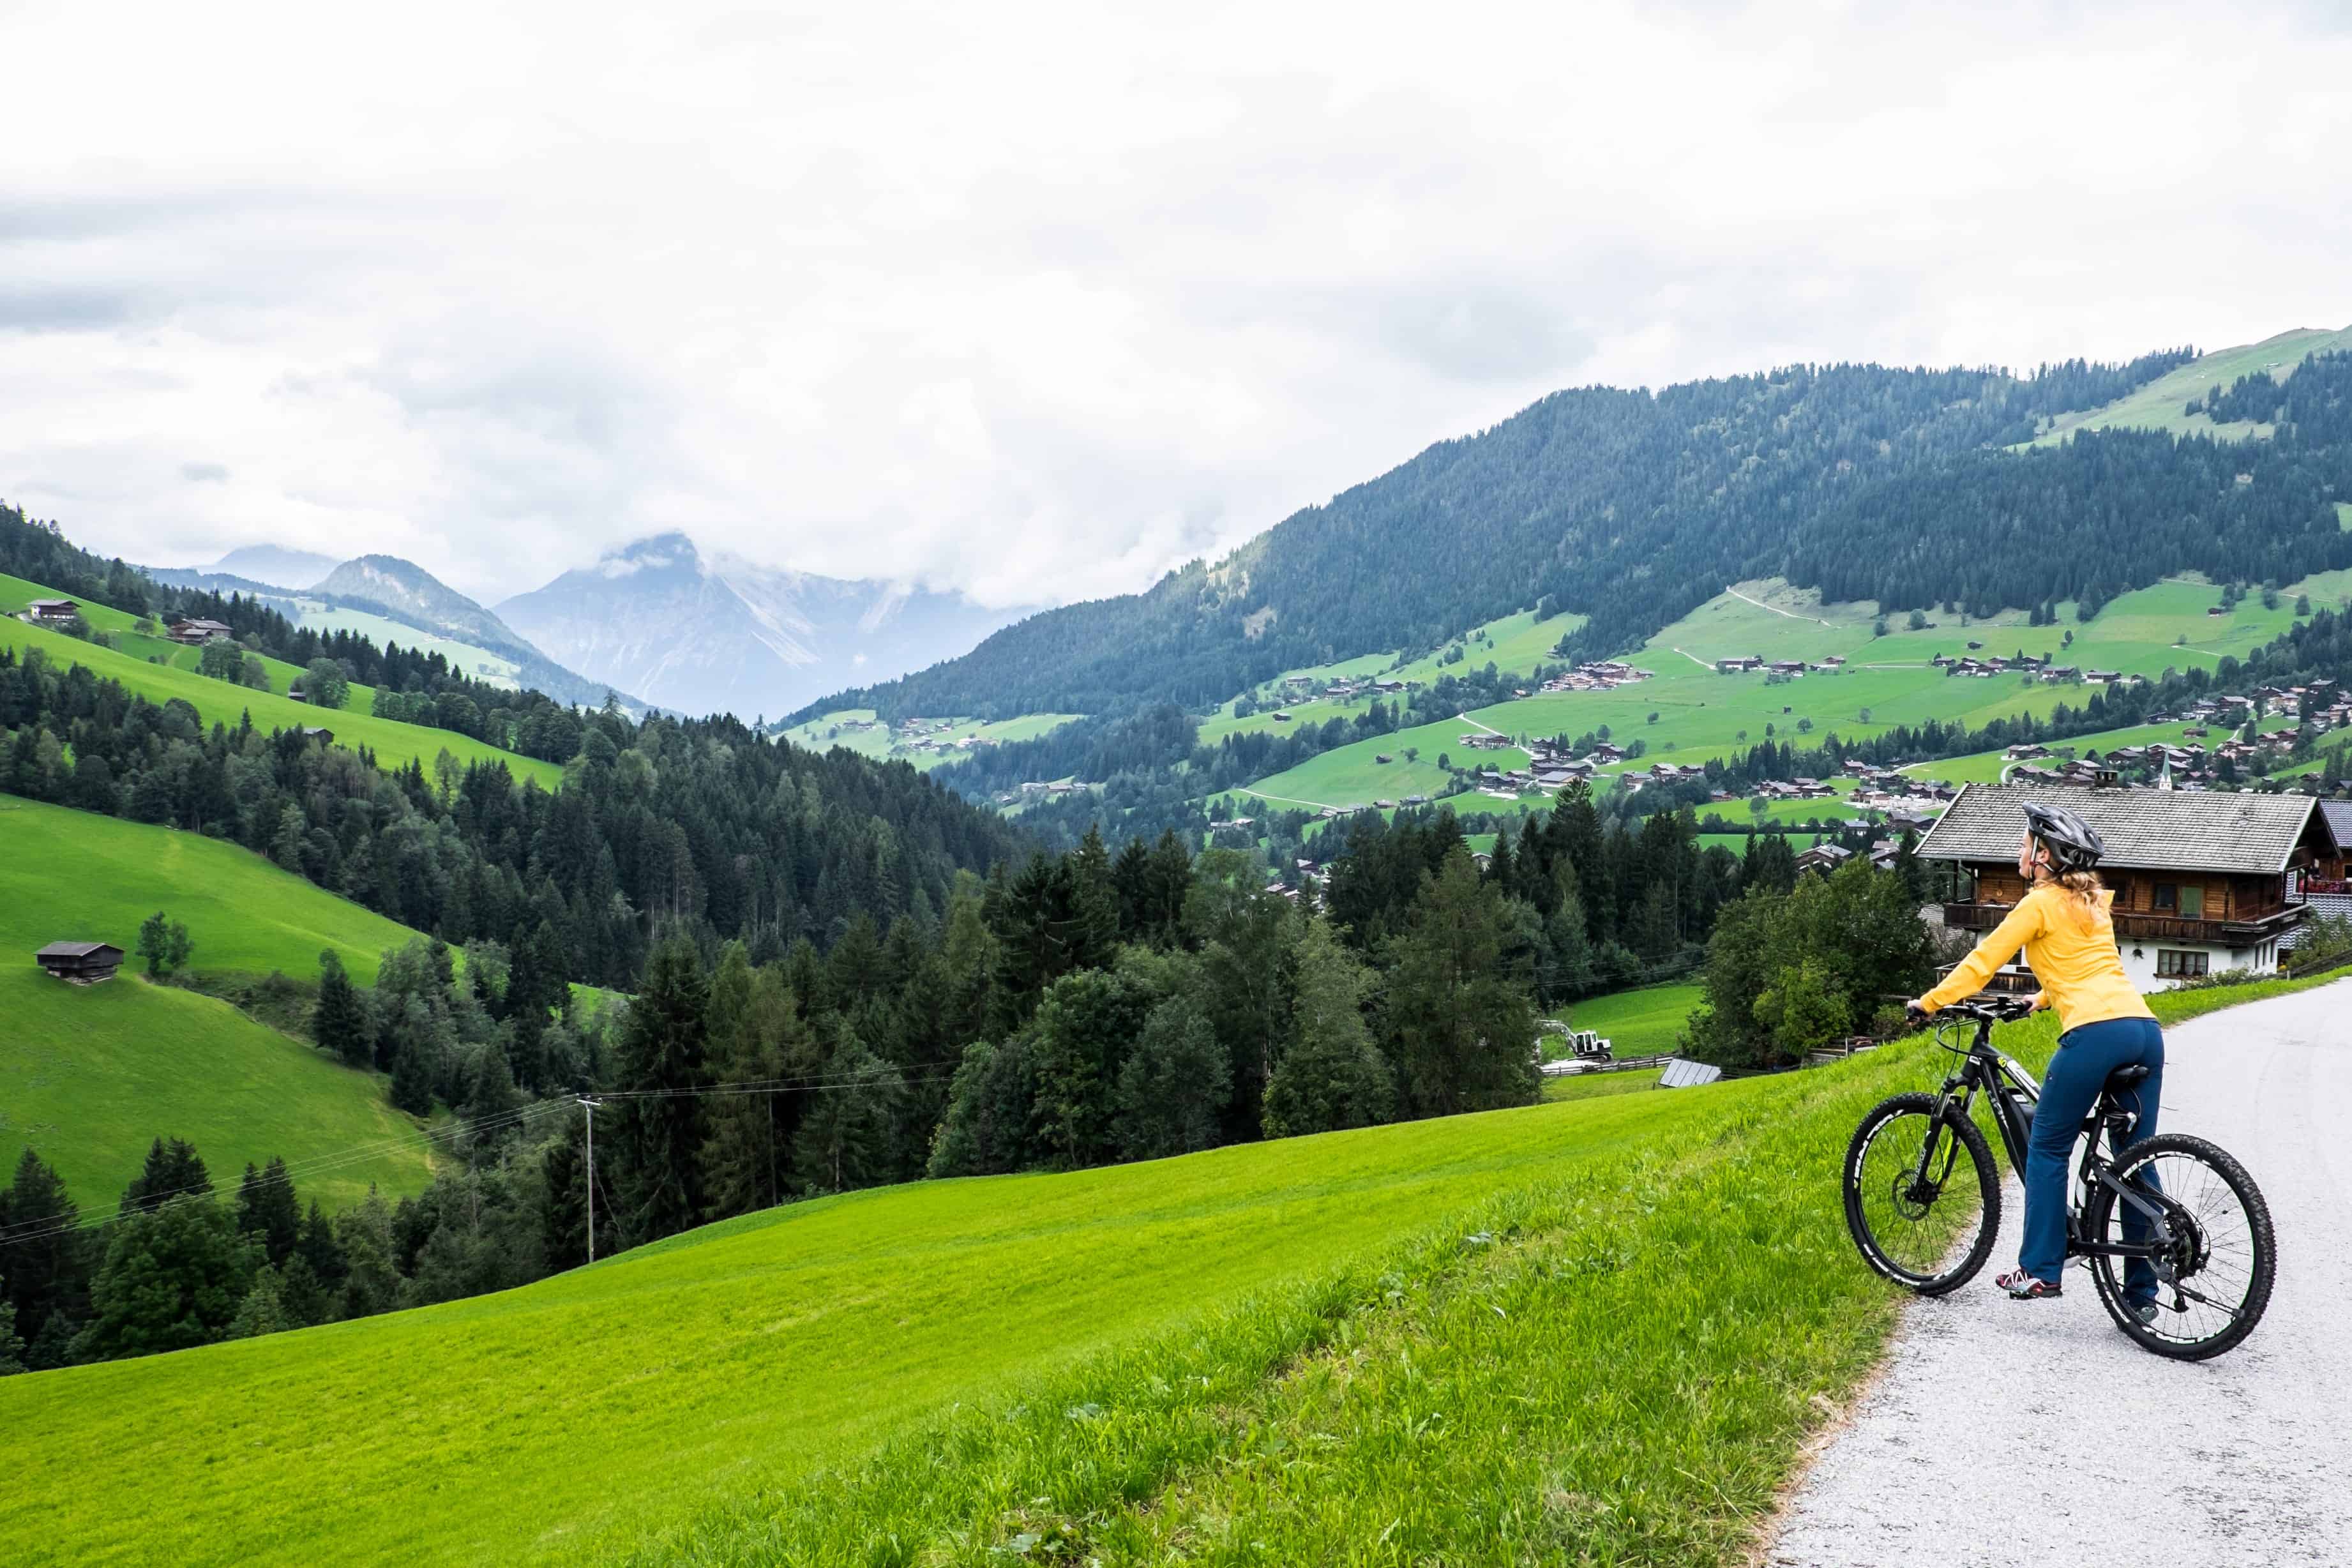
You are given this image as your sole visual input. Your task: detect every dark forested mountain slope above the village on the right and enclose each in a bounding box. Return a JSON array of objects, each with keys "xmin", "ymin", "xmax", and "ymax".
[{"xmin": 825, "ymin": 351, "xmax": 2352, "ymax": 717}]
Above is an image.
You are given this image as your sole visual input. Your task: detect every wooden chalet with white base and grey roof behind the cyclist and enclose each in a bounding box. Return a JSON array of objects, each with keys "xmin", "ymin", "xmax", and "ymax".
[{"xmin": 1919, "ymin": 785, "xmax": 2333, "ymax": 992}]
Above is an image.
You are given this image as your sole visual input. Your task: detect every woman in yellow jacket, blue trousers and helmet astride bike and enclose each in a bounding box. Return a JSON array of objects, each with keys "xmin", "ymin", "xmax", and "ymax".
[{"xmin": 1910, "ymin": 806, "xmax": 2164, "ymax": 1321}]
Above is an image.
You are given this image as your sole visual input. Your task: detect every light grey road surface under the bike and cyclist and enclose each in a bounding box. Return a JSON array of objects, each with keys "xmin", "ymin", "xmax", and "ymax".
[{"xmin": 1761, "ymin": 980, "xmax": 2352, "ymax": 1568}]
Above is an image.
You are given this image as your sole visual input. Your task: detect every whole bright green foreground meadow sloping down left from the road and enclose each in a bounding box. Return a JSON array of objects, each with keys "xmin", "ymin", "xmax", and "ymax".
[{"xmin": 0, "ymin": 985, "xmax": 2314, "ymax": 1564}]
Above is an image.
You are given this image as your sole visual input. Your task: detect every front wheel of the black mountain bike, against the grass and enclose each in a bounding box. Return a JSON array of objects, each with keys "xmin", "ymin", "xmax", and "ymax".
[{"xmin": 1844, "ymin": 1093, "xmax": 2001, "ymax": 1295}]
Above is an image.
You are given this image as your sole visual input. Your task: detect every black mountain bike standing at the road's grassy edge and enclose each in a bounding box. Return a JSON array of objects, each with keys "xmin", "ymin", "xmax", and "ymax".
[{"xmin": 1844, "ymin": 997, "xmax": 2277, "ymax": 1361}]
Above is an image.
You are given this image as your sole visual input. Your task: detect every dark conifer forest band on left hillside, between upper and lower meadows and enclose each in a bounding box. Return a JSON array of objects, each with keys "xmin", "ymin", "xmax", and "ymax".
[{"xmin": 0, "ymin": 649, "xmax": 1023, "ymax": 990}]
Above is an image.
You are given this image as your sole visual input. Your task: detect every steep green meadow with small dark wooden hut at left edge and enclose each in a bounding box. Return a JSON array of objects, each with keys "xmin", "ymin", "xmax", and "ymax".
[{"xmin": 0, "ymin": 795, "xmax": 428, "ymax": 1210}]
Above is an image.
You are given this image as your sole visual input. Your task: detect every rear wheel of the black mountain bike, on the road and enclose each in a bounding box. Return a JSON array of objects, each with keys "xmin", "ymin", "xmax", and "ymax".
[{"xmin": 2081, "ymin": 1133, "xmax": 2279, "ymax": 1361}]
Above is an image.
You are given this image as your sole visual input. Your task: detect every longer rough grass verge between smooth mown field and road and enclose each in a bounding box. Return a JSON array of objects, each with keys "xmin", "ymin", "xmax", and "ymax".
[{"xmin": 628, "ymin": 983, "xmax": 2342, "ymax": 1565}]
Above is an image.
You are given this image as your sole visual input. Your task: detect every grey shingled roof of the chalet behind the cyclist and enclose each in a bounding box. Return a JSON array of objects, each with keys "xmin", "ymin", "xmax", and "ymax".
[{"xmin": 1919, "ymin": 785, "xmax": 2319, "ymax": 877}]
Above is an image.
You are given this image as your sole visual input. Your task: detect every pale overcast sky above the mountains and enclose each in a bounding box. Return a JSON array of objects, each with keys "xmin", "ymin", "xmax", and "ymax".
[{"xmin": 0, "ymin": 0, "xmax": 2352, "ymax": 604}]
